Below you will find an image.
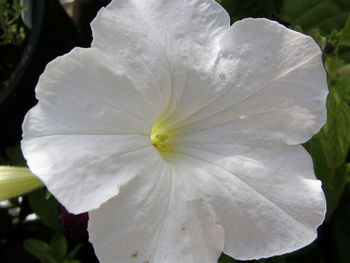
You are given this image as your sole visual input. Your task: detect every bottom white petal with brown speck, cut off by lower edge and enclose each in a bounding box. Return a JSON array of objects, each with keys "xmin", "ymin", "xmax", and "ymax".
[{"xmin": 89, "ymin": 162, "xmax": 224, "ymax": 263}]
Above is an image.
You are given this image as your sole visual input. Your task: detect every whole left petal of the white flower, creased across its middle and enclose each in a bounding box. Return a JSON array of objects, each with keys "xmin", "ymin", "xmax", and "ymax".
[{"xmin": 22, "ymin": 48, "xmax": 163, "ymax": 213}]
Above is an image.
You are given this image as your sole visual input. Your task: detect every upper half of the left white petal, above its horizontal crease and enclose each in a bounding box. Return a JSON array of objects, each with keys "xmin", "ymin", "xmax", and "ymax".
[{"xmin": 23, "ymin": 48, "xmax": 158, "ymax": 137}]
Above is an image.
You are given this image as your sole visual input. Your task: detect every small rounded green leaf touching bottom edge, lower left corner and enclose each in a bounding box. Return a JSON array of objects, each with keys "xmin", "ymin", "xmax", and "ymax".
[{"xmin": 23, "ymin": 239, "xmax": 59, "ymax": 263}]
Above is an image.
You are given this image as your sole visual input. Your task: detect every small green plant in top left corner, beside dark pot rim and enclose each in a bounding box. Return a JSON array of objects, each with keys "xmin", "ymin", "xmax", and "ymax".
[{"xmin": 0, "ymin": 0, "xmax": 26, "ymax": 46}]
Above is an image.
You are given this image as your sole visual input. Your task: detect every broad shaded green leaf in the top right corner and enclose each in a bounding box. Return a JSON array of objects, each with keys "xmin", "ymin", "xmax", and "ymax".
[{"xmin": 281, "ymin": 0, "xmax": 350, "ymax": 34}]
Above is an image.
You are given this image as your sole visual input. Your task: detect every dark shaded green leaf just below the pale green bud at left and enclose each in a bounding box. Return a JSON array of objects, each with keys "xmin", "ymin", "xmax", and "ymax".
[{"xmin": 28, "ymin": 188, "xmax": 60, "ymax": 231}]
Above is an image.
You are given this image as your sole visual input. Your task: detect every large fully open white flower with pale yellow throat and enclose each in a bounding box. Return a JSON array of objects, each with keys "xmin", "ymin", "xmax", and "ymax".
[{"xmin": 22, "ymin": 0, "xmax": 327, "ymax": 263}]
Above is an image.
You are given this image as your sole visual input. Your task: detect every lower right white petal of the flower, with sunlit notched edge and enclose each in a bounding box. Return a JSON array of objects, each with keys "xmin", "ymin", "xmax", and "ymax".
[{"xmin": 169, "ymin": 141, "xmax": 325, "ymax": 260}]
